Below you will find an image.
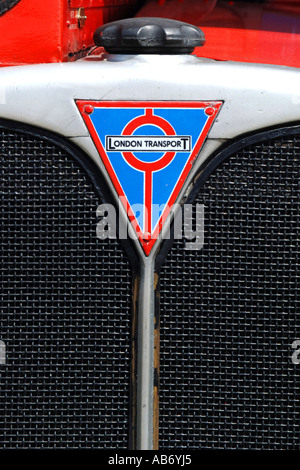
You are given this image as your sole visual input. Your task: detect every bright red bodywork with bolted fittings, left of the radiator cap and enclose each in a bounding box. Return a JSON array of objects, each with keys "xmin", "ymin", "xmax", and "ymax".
[{"xmin": 0, "ymin": 0, "xmax": 138, "ymax": 66}]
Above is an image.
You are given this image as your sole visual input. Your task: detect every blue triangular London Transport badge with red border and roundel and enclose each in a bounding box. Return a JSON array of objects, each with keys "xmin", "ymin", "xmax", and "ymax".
[{"xmin": 77, "ymin": 100, "xmax": 222, "ymax": 256}]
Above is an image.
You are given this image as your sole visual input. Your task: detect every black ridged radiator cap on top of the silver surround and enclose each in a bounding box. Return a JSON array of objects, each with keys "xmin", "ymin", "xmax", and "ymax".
[{"xmin": 94, "ymin": 18, "xmax": 205, "ymax": 54}]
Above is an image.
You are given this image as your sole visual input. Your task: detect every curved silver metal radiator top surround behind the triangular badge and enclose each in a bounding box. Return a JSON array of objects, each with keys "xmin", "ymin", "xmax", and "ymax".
[{"xmin": 0, "ymin": 55, "xmax": 300, "ymax": 139}]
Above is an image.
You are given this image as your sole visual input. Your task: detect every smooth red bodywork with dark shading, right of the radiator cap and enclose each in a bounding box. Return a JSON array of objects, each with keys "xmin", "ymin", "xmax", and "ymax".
[{"xmin": 138, "ymin": 0, "xmax": 300, "ymax": 67}]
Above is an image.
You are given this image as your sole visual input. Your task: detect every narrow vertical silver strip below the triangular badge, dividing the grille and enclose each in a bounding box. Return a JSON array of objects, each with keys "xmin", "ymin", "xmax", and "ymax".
[{"xmin": 136, "ymin": 256, "xmax": 154, "ymax": 450}]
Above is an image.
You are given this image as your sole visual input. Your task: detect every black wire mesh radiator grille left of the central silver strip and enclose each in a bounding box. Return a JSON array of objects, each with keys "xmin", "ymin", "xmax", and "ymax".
[{"xmin": 0, "ymin": 125, "xmax": 131, "ymax": 448}]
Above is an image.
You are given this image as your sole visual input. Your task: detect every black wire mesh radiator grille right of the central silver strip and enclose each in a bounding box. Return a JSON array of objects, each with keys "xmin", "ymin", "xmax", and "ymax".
[{"xmin": 160, "ymin": 137, "xmax": 300, "ymax": 449}]
